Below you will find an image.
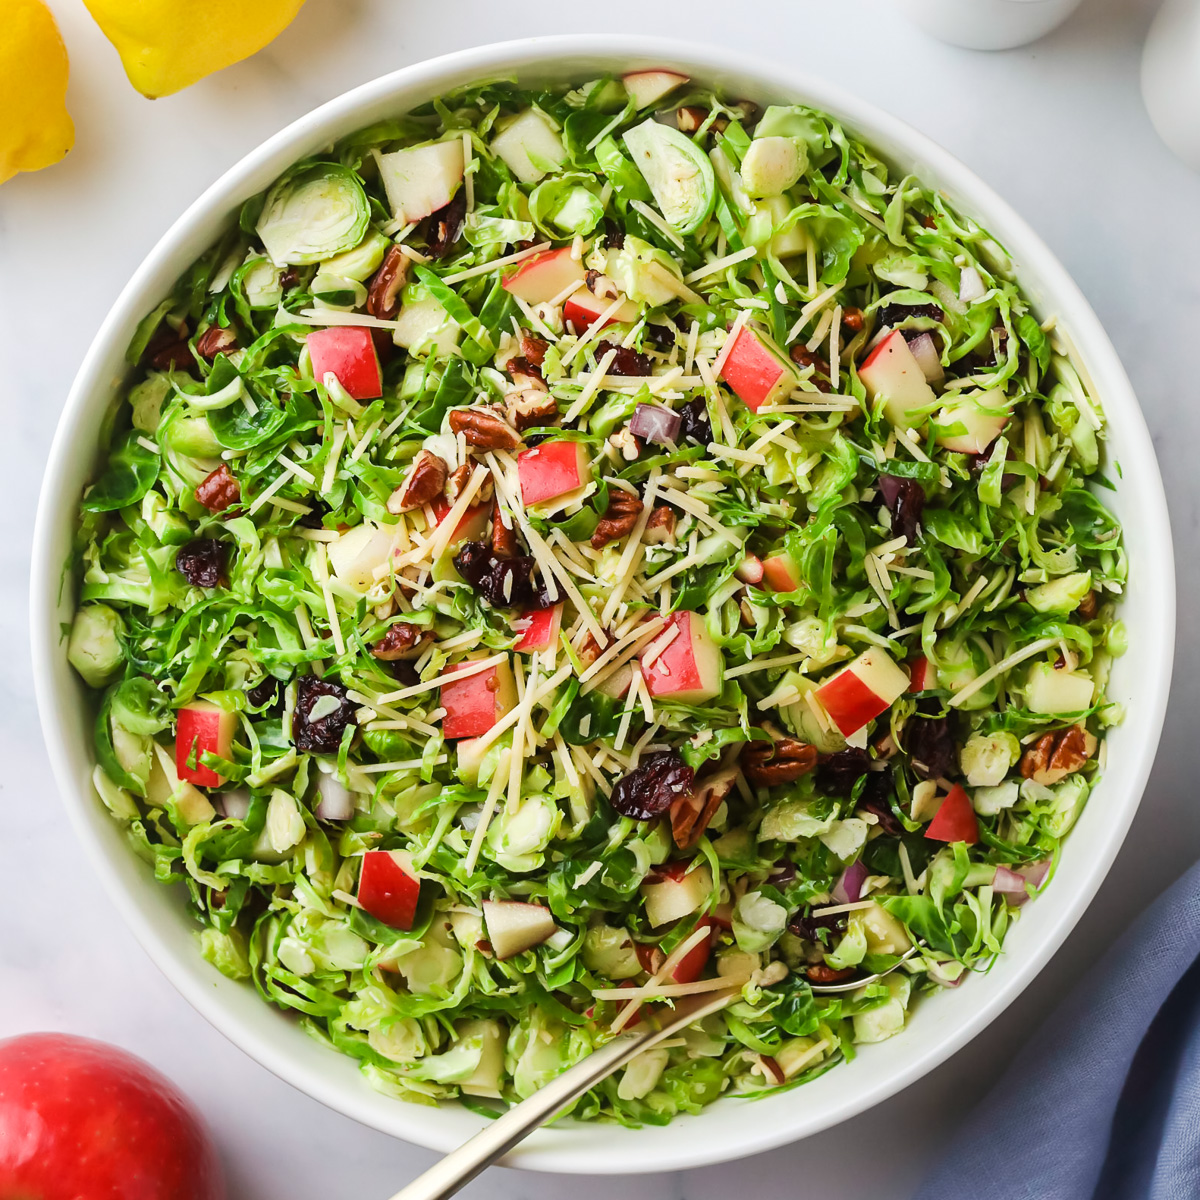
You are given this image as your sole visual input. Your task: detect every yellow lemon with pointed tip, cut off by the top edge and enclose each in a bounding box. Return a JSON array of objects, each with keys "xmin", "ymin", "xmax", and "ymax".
[{"xmin": 84, "ymin": 0, "xmax": 304, "ymax": 98}]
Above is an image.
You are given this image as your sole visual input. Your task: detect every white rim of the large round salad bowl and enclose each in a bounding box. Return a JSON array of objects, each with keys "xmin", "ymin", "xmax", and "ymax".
[{"xmin": 30, "ymin": 34, "xmax": 1175, "ymax": 1175}]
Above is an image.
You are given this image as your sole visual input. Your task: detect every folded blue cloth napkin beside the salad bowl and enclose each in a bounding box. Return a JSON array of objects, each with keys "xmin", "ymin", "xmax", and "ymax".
[{"xmin": 913, "ymin": 863, "xmax": 1200, "ymax": 1200}]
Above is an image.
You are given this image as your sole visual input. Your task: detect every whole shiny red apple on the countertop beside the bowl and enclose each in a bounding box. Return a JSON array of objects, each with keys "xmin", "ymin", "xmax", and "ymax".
[{"xmin": 0, "ymin": 1033, "xmax": 227, "ymax": 1200}]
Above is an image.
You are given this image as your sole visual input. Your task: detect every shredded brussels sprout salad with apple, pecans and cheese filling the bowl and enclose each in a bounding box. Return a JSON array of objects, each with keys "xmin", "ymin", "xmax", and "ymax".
[{"xmin": 68, "ymin": 72, "xmax": 1126, "ymax": 1124}]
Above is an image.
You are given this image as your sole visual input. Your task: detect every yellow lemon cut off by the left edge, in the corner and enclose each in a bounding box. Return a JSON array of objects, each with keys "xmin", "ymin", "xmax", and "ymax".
[{"xmin": 0, "ymin": 0, "xmax": 74, "ymax": 184}]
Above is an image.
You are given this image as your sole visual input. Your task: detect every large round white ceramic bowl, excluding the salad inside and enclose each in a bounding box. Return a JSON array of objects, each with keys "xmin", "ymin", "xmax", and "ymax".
[{"xmin": 32, "ymin": 36, "xmax": 1175, "ymax": 1175}]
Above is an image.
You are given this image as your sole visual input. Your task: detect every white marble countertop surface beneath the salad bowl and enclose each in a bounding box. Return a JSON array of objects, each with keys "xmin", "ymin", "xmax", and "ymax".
[{"xmin": 0, "ymin": 0, "xmax": 1200, "ymax": 1200}]
